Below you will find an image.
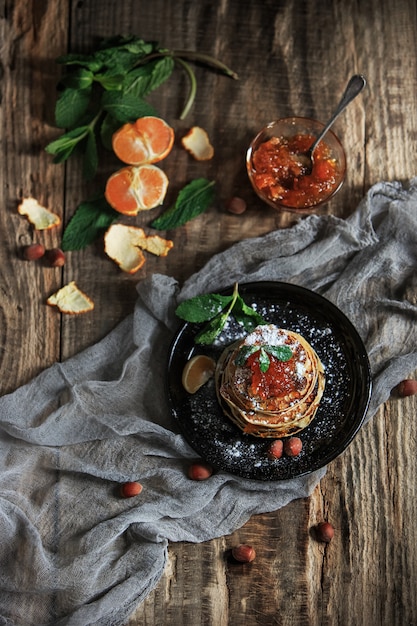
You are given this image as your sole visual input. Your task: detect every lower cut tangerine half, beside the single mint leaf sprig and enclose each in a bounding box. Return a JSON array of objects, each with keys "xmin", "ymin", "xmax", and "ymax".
[{"xmin": 105, "ymin": 165, "xmax": 168, "ymax": 215}]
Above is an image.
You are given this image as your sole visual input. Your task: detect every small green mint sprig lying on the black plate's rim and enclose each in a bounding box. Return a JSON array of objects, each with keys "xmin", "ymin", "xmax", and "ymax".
[{"xmin": 175, "ymin": 283, "xmax": 267, "ymax": 345}]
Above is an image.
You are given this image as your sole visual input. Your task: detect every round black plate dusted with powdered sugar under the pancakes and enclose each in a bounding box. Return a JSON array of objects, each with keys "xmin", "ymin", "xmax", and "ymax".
[{"xmin": 168, "ymin": 282, "xmax": 371, "ymax": 480}]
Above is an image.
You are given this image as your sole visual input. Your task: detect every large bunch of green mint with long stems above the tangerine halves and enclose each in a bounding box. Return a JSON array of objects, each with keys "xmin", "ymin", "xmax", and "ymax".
[{"xmin": 46, "ymin": 36, "xmax": 237, "ymax": 179}]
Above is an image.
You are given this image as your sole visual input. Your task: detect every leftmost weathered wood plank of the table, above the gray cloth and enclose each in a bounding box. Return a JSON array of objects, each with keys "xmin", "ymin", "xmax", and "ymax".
[{"xmin": 0, "ymin": 2, "xmax": 68, "ymax": 394}]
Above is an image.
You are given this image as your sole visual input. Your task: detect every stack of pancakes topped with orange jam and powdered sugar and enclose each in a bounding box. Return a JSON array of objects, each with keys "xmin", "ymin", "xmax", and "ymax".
[{"xmin": 216, "ymin": 324, "xmax": 325, "ymax": 438}]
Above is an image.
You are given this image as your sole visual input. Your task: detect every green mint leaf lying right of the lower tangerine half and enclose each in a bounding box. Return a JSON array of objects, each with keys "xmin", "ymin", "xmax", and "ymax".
[{"xmin": 151, "ymin": 178, "xmax": 215, "ymax": 230}]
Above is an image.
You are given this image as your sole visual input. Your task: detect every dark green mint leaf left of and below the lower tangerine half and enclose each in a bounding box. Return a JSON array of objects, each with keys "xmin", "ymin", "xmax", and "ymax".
[{"xmin": 61, "ymin": 196, "xmax": 120, "ymax": 250}]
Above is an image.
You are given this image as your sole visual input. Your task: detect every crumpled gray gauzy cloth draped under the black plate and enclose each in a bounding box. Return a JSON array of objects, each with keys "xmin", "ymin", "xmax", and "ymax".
[{"xmin": 0, "ymin": 179, "xmax": 417, "ymax": 626}]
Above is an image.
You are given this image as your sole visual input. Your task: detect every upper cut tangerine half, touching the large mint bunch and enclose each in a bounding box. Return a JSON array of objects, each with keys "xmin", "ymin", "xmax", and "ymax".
[{"xmin": 112, "ymin": 116, "xmax": 174, "ymax": 165}]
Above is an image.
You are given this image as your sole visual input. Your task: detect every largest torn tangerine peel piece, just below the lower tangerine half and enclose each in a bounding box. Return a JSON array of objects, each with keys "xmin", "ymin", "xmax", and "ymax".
[{"xmin": 104, "ymin": 224, "xmax": 174, "ymax": 274}]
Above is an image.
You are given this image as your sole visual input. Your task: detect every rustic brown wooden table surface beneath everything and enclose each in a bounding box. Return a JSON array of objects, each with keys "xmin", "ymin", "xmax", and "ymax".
[{"xmin": 0, "ymin": 0, "xmax": 417, "ymax": 626}]
